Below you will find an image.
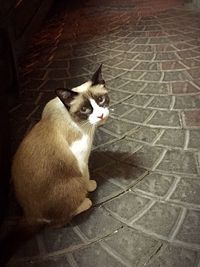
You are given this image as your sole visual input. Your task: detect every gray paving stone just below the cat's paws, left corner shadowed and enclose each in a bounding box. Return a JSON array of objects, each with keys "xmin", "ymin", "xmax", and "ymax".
[{"xmin": 72, "ymin": 208, "xmax": 121, "ymax": 240}]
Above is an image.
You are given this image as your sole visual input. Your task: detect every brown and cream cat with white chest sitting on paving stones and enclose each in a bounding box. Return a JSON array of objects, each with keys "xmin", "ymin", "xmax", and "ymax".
[{"xmin": 12, "ymin": 66, "xmax": 109, "ymax": 227}]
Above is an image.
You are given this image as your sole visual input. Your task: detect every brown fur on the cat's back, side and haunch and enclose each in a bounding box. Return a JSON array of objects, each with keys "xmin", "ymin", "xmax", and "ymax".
[{"xmin": 12, "ymin": 96, "xmax": 97, "ymax": 228}]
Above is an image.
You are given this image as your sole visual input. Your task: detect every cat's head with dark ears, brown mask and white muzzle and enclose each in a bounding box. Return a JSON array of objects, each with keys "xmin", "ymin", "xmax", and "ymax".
[{"xmin": 56, "ymin": 65, "xmax": 109, "ymax": 125}]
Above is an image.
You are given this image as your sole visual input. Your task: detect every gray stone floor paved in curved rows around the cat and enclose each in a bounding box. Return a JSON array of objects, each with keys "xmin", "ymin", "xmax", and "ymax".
[{"xmin": 6, "ymin": 0, "xmax": 200, "ymax": 267}]
